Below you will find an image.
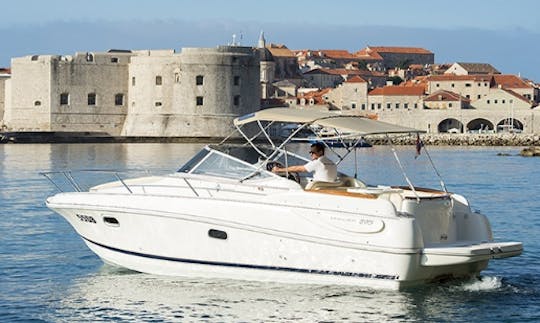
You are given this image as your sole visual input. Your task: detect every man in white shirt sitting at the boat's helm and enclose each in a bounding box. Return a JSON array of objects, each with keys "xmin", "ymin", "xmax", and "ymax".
[{"xmin": 272, "ymin": 142, "xmax": 337, "ymax": 182}]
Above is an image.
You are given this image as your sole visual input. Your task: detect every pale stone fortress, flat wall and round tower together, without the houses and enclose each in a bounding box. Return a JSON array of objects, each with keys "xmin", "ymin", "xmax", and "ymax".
[{"xmin": 3, "ymin": 46, "xmax": 260, "ymax": 137}]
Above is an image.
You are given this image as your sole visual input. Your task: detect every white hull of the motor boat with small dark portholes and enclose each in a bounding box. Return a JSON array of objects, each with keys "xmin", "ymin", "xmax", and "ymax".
[{"xmin": 48, "ymin": 185, "xmax": 521, "ymax": 289}]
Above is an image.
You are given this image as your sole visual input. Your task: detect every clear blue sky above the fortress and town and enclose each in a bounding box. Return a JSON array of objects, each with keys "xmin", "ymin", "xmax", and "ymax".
[{"xmin": 0, "ymin": 0, "xmax": 540, "ymax": 82}]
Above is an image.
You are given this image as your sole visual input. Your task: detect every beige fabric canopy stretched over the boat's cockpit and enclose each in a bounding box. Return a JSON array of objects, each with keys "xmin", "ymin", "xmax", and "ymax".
[{"xmin": 234, "ymin": 108, "xmax": 425, "ymax": 136}]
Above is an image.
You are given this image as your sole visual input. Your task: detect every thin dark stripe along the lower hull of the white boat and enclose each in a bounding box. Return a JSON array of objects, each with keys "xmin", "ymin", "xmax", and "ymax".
[{"xmin": 81, "ymin": 236, "xmax": 399, "ymax": 280}]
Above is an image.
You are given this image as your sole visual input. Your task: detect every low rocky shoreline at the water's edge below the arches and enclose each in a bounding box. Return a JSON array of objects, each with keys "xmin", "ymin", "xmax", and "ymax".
[{"xmin": 368, "ymin": 133, "xmax": 540, "ymax": 146}]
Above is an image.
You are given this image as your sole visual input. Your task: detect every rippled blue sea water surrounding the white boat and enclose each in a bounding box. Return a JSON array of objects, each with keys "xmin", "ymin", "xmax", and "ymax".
[{"xmin": 0, "ymin": 144, "xmax": 540, "ymax": 322}]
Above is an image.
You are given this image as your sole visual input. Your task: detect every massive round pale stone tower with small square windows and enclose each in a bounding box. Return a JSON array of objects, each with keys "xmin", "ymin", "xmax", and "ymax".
[{"xmin": 122, "ymin": 46, "xmax": 261, "ymax": 137}]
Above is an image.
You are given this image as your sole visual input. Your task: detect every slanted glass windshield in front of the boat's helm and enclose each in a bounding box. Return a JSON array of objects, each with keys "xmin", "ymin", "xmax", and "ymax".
[{"xmin": 178, "ymin": 147, "xmax": 271, "ymax": 179}]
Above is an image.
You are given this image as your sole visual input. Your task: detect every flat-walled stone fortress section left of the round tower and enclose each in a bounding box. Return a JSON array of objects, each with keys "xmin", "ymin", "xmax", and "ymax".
[{"xmin": 4, "ymin": 51, "xmax": 133, "ymax": 135}]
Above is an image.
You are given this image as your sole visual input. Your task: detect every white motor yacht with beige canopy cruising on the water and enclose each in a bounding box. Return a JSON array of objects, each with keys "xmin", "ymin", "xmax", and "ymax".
[{"xmin": 43, "ymin": 108, "xmax": 523, "ymax": 289}]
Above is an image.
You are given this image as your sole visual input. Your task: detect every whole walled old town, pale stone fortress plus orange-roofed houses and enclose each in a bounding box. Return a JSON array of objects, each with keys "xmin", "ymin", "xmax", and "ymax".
[{"xmin": 0, "ymin": 32, "xmax": 540, "ymax": 138}]
